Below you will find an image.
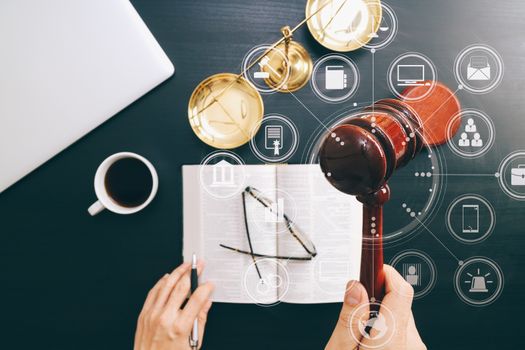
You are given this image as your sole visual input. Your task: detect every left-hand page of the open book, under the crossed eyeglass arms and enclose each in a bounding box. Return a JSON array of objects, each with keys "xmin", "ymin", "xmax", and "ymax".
[{"xmin": 183, "ymin": 165, "xmax": 279, "ymax": 304}]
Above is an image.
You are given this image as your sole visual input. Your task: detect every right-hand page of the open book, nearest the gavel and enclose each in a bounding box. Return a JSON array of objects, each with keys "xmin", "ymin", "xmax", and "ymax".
[{"xmin": 276, "ymin": 165, "xmax": 362, "ymax": 303}]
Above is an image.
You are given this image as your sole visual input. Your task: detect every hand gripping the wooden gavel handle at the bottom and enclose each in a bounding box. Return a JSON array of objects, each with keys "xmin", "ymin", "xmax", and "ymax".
[{"xmin": 325, "ymin": 265, "xmax": 426, "ymax": 350}]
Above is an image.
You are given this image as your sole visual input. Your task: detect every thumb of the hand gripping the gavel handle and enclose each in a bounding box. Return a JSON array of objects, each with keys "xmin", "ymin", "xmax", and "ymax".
[{"xmin": 325, "ymin": 281, "xmax": 369, "ymax": 350}]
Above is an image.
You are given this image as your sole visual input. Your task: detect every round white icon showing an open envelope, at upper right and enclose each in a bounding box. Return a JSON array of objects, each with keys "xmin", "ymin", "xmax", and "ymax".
[{"xmin": 454, "ymin": 45, "xmax": 504, "ymax": 94}]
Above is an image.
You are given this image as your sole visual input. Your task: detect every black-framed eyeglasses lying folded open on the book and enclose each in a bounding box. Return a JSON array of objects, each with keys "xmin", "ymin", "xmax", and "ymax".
[{"xmin": 219, "ymin": 186, "xmax": 317, "ymax": 279}]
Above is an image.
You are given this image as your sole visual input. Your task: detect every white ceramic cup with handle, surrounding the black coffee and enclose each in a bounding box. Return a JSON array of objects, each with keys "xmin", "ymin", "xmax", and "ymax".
[{"xmin": 88, "ymin": 152, "xmax": 159, "ymax": 216}]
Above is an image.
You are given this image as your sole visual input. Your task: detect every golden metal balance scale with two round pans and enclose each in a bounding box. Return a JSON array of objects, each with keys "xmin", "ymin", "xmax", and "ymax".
[{"xmin": 188, "ymin": 0, "xmax": 382, "ymax": 149}]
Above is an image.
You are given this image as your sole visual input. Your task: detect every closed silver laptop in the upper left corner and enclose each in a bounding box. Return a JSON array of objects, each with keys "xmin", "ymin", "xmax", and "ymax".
[{"xmin": 0, "ymin": 0, "xmax": 174, "ymax": 192}]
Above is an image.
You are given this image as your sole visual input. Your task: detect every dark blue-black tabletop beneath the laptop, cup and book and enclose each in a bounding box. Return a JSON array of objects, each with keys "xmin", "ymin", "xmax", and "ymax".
[{"xmin": 0, "ymin": 0, "xmax": 525, "ymax": 350}]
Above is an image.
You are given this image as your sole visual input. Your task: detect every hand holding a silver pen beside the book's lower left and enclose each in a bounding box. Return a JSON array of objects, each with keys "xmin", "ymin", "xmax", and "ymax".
[{"xmin": 134, "ymin": 262, "xmax": 213, "ymax": 350}]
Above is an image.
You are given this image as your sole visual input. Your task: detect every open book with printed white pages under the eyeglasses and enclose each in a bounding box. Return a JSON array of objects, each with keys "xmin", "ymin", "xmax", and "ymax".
[{"xmin": 183, "ymin": 165, "xmax": 362, "ymax": 304}]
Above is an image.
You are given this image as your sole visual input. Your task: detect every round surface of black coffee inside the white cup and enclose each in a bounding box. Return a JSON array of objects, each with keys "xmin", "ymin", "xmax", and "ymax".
[{"xmin": 105, "ymin": 158, "xmax": 153, "ymax": 207}]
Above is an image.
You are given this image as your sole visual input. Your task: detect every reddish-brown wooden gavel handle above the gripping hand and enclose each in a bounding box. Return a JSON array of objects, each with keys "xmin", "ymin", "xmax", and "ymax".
[{"xmin": 360, "ymin": 204, "xmax": 385, "ymax": 302}]
